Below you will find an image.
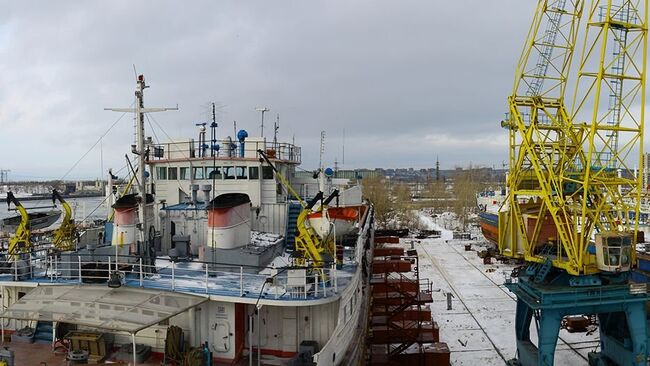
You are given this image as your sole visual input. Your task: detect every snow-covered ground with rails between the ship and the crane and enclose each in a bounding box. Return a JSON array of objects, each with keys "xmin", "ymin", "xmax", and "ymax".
[{"xmin": 404, "ymin": 214, "xmax": 598, "ymax": 366}]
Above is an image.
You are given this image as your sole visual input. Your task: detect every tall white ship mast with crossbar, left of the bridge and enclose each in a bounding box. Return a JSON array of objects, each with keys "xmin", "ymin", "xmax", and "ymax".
[{"xmin": 104, "ymin": 75, "xmax": 178, "ymax": 259}]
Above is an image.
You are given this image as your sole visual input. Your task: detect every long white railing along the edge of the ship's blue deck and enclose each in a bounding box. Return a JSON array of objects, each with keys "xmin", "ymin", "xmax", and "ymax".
[{"xmin": 7, "ymin": 254, "xmax": 347, "ymax": 300}]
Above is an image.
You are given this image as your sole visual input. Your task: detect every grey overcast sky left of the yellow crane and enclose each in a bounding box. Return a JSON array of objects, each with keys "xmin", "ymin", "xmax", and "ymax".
[{"xmin": 0, "ymin": 0, "xmax": 536, "ymax": 179}]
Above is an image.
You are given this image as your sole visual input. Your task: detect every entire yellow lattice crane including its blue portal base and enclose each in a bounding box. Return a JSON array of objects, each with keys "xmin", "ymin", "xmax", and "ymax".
[{"xmin": 499, "ymin": 0, "xmax": 650, "ymax": 366}]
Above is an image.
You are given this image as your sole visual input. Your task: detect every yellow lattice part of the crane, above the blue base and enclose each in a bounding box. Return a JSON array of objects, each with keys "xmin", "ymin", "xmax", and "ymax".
[{"xmin": 499, "ymin": 0, "xmax": 647, "ymax": 275}]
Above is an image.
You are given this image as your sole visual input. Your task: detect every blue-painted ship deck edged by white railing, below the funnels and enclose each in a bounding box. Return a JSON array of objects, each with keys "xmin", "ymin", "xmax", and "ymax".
[{"xmin": 0, "ymin": 256, "xmax": 358, "ymax": 306}]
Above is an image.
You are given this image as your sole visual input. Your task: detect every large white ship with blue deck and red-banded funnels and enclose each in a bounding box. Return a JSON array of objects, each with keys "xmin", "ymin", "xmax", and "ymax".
[{"xmin": 0, "ymin": 76, "xmax": 374, "ymax": 365}]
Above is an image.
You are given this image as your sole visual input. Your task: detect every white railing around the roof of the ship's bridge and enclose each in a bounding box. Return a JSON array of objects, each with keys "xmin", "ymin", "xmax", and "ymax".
[{"xmin": 149, "ymin": 139, "xmax": 302, "ymax": 163}]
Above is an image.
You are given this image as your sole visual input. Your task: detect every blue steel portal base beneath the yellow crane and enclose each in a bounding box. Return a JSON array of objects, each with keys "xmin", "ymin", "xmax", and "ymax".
[{"xmin": 506, "ymin": 274, "xmax": 650, "ymax": 366}]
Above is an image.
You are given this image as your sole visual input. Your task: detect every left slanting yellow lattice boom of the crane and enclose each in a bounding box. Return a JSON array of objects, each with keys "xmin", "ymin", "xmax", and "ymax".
[{"xmin": 499, "ymin": 0, "xmax": 583, "ymax": 274}]
